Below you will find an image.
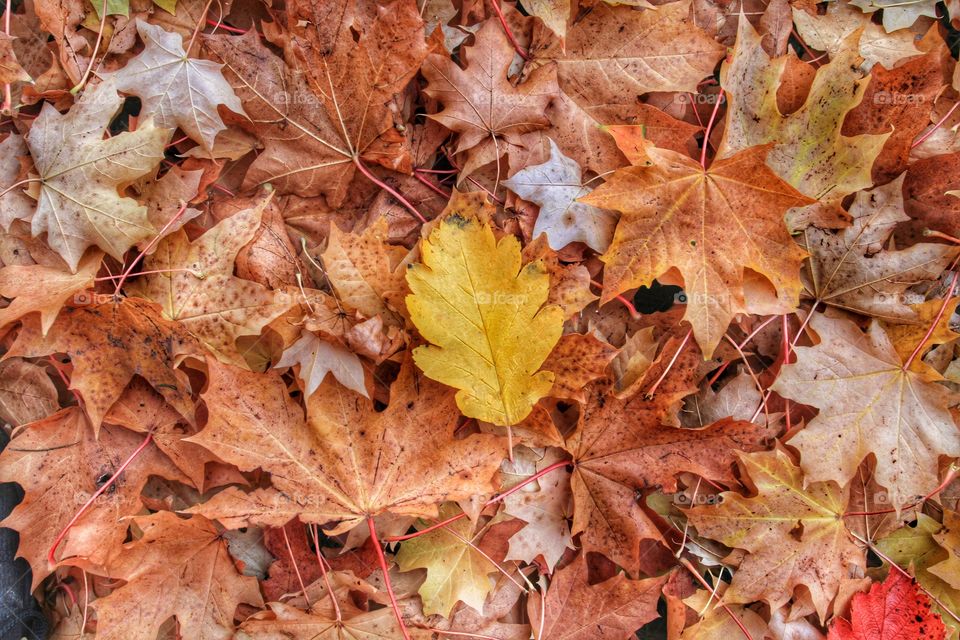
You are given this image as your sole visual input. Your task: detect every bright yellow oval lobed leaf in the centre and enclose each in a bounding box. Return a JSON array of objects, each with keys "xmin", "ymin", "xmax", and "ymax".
[{"xmin": 406, "ymin": 215, "xmax": 563, "ymax": 426}]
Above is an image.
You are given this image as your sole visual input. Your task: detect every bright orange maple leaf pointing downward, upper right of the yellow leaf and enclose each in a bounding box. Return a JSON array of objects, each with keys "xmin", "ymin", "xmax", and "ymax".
[{"xmin": 582, "ymin": 146, "xmax": 813, "ymax": 357}]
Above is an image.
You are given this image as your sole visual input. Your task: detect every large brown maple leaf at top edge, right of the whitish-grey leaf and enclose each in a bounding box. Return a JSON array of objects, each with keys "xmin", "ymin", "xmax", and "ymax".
[{"xmin": 204, "ymin": 0, "xmax": 429, "ymax": 206}]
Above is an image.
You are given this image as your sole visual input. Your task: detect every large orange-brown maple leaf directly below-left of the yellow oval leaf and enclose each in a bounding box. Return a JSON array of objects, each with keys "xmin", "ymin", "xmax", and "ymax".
[{"xmin": 184, "ymin": 361, "xmax": 503, "ymax": 533}]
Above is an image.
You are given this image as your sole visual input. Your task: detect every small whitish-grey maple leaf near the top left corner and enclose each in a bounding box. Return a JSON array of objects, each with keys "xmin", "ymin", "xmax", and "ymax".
[{"xmin": 105, "ymin": 20, "xmax": 245, "ymax": 149}]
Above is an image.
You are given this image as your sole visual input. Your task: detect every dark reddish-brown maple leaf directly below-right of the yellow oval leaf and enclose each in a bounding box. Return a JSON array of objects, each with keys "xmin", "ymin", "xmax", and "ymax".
[{"xmin": 565, "ymin": 344, "xmax": 775, "ymax": 572}]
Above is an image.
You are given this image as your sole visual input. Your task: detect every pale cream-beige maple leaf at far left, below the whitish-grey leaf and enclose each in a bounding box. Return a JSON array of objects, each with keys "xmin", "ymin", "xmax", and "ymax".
[{"xmin": 25, "ymin": 80, "xmax": 170, "ymax": 271}]
